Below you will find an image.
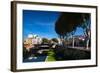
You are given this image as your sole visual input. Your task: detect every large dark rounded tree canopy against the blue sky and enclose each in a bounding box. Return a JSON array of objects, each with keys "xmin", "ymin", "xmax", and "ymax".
[{"xmin": 55, "ymin": 12, "xmax": 90, "ymax": 45}]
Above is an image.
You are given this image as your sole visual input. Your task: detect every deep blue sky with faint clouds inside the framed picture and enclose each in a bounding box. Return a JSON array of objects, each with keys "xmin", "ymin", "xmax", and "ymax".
[{"xmin": 23, "ymin": 10, "xmax": 83, "ymax": 38}]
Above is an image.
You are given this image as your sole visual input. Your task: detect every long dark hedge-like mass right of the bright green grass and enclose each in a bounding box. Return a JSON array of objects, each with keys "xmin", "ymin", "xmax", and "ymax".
[{"xmin": 54, "ymin": 47, "xmax": 91, "ymax": 61}]
